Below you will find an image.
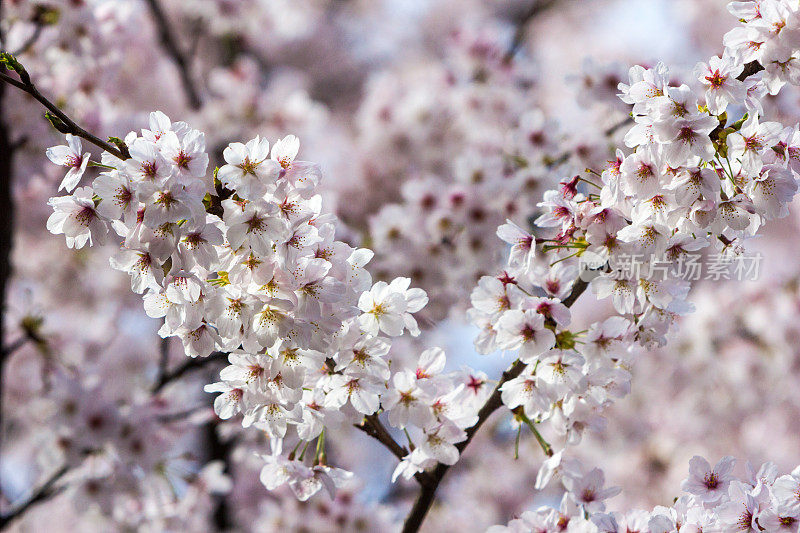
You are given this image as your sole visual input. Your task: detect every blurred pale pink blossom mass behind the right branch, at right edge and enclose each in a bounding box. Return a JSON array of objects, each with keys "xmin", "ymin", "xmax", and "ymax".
[{"xmin": 574, "ymin": 270, "xmax": 800, "ymax": 508}]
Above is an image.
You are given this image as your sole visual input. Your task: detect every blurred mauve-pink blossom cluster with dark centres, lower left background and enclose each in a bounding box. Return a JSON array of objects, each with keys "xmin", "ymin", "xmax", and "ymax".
[{"xmin": 41, "ymin": 373, "xmax": 232, "ymax": 528}]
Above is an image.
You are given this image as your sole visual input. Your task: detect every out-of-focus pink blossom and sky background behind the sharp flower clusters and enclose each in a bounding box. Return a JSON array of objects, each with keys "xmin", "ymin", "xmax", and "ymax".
[{"xmin": 0, "ymin": 0, "xmax": 800, "ymax": 531}]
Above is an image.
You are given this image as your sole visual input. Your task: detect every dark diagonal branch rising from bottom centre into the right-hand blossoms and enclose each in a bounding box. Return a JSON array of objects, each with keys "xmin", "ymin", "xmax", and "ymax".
[{"xmin": 403, "ymin": 279, "xmax": 589, "ymax": 533}]
